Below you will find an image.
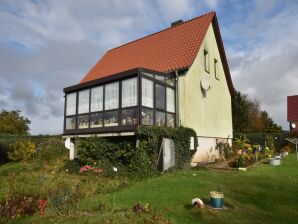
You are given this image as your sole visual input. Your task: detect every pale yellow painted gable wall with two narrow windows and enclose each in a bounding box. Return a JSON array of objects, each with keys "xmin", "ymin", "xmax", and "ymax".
[{"xmin": 179, "ymin": 23, "xmax": 233, "ymax": 138}]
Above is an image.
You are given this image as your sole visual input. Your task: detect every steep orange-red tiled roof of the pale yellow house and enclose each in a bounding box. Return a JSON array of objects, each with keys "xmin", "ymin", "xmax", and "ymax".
[{"xmin": 80, "ymin": 12, "xmax": 235, "ymax": 94}]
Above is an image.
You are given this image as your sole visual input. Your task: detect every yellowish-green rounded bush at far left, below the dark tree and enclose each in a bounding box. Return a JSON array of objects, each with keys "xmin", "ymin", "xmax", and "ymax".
[{"xmin": 8, "ymin": 140, "xmax": 36, "ymax": 161}]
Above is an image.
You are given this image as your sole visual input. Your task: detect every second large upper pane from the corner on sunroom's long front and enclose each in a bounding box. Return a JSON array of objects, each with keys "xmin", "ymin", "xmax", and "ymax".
[{"xmin": 105, "ymin": 82, "xmax": 119, "ymax": 110}]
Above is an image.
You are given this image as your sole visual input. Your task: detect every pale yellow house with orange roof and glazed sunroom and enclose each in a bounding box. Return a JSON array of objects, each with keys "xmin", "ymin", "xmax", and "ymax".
[{"xmin": 64, "ymin": 12, "xmax": 235, "ymax": 162}]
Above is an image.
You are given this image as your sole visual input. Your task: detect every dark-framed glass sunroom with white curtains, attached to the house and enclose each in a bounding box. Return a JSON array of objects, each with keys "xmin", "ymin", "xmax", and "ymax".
[{"xmin": 64, "ymin": 68, "xmax": 176, "ymax": 135}]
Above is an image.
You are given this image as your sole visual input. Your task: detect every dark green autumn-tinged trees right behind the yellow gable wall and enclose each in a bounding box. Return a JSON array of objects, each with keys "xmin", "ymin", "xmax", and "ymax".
[{"xmin": 232, "ymin": 92, "xmax": 282, "ymax": 132}]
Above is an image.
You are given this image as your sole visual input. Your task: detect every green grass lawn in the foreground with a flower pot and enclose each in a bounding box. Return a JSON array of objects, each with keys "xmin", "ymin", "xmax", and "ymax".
[{"xmin": 0, "ymin": 154, "xmax": 298, "ymax": 223}]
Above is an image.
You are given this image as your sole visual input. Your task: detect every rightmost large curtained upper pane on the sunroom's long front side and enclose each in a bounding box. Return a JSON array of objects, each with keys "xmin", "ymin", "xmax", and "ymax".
[{"xmin": 122, "ymin": 78, "xmax": 138, "ymax": 107}]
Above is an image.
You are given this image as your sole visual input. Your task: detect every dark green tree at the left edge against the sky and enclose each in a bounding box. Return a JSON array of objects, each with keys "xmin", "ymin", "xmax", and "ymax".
[{"xmin": 0, "ymin": 110, "xmax": 31, "ymax": 135}]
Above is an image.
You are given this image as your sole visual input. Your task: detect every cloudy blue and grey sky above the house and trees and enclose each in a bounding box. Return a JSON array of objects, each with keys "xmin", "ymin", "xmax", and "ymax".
[{"xmin": 0, "ymin": 0, "xmax": 298, "ymax": 134}]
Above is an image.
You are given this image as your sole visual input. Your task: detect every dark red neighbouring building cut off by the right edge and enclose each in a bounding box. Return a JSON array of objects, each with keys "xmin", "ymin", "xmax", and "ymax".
[{"xmin": 287, "ymin": 95, "xmax": 298, "ymax": 131}]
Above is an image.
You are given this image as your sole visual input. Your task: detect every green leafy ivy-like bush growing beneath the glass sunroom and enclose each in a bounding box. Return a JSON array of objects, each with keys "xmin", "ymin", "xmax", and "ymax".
[{"xmin": 78, "ymin": 126, "xmax": 198, "ymax": 177}]
